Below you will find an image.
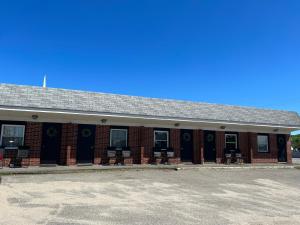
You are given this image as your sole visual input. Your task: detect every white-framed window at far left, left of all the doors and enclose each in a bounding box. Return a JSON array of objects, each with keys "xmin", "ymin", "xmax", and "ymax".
[{"xmin": 1, "ymin": 124, "xmax": 25, "ymax": 148}]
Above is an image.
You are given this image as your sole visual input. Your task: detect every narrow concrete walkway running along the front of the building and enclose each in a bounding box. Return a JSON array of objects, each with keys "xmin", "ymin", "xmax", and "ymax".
[{"xmin": 0, "ymin": 163, "xmax": 295, "ymax": 176}]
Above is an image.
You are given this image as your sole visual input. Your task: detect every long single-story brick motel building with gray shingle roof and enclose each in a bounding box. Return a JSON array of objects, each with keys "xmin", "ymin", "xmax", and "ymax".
[{"xmin": 0, "ymin": 84, "xmax": 300, "ymax": 165}]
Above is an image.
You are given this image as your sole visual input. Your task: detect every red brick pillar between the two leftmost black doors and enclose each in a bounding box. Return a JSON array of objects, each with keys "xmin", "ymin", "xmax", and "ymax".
[{"xmin": 60, "ymin": 123, "xmax": 78, "ymax": 166}]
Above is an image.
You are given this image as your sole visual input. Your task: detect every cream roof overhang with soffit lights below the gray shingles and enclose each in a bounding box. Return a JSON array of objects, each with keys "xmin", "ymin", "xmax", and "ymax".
[{"xmin": 0, "ymin": 106, "xmax": 300, "ymax": 133}]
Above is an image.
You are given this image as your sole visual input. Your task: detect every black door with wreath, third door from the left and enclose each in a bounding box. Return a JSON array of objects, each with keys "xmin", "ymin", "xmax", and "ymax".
[{"xmin": 180, "ymin": 130, "xmax": 193, "ymax": 161}]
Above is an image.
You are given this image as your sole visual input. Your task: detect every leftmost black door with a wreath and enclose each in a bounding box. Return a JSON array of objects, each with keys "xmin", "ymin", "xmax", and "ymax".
[{"xmin": 41, "ymin": 123, "xmax": 61, "ymax": 164}]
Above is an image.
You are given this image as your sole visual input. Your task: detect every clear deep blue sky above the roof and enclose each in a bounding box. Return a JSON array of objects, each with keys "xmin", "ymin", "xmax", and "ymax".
[{"xmin": 0, "ymin": 0, "xmax": 300, "ymax": 132}]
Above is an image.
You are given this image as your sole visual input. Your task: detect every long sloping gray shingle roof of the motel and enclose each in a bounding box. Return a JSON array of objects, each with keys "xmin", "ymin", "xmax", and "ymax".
[{"xmin": 0, "ymin": 84, "xmax": 300, "ymax": 127}]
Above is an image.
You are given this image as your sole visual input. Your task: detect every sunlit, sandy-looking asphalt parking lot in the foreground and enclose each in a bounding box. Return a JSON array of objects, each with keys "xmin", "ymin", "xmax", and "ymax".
[{"xmin": 0, "ymin": 168, "xmax": 300, "ymax": 225}]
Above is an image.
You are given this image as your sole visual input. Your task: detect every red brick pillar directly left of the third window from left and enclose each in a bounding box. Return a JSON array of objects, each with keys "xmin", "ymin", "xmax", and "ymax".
[{"xmin": 140, "ymin": 127, "xmax": 154, "ymax": 164}]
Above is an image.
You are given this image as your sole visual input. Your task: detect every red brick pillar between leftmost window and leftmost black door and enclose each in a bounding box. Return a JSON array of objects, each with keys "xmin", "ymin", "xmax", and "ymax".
[{"xmin": 24, "ymin": 122, "xmax": 43, "ymax": 166}]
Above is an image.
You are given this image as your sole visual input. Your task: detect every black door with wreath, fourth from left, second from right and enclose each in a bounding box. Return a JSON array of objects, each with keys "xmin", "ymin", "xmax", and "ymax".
[{"xmin": 204, "ymin": 131, "xmax": 216, "ymax": 161}]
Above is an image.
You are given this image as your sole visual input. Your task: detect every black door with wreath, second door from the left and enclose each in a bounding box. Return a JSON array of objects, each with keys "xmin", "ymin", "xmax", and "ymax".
[{"xmin": 77, "ymin": 124, "xmax": 95, "ymax": 163}]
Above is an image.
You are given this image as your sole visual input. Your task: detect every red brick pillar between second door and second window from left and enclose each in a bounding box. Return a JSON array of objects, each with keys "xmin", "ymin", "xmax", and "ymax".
[{"xmin": 94, "ymin": 125, "xmax": 110, "ymax": 164}]
